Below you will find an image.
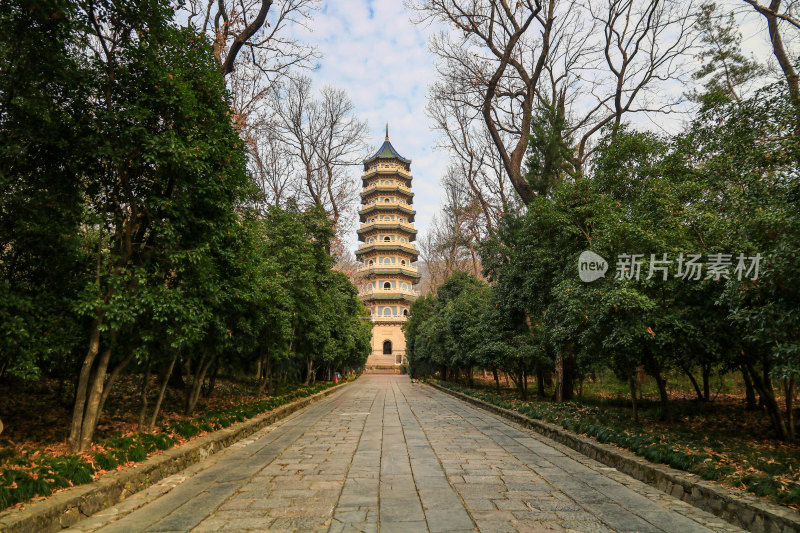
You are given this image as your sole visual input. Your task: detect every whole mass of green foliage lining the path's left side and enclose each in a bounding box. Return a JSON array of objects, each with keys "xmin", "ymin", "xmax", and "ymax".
[{"xmin": 0, "ymin": 0, "xmax": 370, "ymax": 448}]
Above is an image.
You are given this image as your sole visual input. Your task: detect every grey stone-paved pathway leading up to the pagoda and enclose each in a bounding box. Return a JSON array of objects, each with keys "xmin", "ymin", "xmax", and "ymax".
[{"xmin": 70, "ymin": 375, "xmax": 741, "ymax": 533}]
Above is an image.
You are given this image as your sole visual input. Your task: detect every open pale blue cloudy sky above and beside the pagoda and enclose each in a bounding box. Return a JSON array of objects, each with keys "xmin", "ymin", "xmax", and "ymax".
[{"xmin": 298, "ymin": 0, "xmax": 447, "ymax": 254}]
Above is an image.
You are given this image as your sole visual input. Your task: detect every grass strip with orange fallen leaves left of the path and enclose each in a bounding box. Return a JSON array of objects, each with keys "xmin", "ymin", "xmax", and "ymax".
[{"xmin": 0, "ymin": 382, "xmax": 340, "ymax": 509}]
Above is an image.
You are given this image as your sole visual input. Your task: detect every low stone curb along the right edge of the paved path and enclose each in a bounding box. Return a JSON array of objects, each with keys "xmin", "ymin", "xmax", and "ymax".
[{"xmin": 428, "ymin": 383, "xmax": 800, "ymax": 533}]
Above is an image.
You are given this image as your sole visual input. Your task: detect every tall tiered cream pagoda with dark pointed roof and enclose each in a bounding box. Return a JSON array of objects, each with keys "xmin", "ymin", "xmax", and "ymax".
[{"xmin": 356, "ymin": 124, "xmax": 420, "ymax": 370}]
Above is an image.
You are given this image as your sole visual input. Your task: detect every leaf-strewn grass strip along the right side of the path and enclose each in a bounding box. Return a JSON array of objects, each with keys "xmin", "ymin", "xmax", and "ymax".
[{"xmin": 438, "ymin": 374, "xmax": 800, "ymax": 509}]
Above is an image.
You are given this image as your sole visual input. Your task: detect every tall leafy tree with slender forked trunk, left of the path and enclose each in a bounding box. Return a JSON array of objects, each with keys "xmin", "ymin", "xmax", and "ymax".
[{"xmin": 63, "ymin": 2, "xmax": 247, "ymax": 450}]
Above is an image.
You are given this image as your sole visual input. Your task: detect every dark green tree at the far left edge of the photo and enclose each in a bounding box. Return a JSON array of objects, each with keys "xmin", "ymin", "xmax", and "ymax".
[{"xmin": 0, "ymin": 0, "xmax": 91, "ymax": 390}]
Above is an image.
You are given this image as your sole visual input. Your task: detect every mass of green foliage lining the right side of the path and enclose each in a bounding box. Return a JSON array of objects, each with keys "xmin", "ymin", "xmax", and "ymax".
[{"xmin": 460, "ymin": 81, "xmax": 800, "ymax": 432}]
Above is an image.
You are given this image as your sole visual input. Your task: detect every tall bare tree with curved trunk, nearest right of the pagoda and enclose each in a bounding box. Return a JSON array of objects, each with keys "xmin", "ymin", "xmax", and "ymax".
[{"xmin": 410, "ymin": 0, "xmax": 555, "ymax": 203}]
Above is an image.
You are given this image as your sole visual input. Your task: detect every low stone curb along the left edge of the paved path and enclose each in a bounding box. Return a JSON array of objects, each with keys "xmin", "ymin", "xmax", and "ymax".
[{"xmin": 0, "ymin": 381, "xmax": 351, "ymax": 533}]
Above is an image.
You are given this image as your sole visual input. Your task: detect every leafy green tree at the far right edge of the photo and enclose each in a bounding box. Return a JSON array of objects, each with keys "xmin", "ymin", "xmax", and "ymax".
[{"xmin": 676, "ymin": 84, "xmax": 798, "ymax": 439}]
